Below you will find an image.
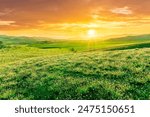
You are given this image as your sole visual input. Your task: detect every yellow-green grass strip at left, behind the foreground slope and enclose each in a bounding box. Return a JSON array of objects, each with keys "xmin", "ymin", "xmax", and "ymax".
[{"xmin": 0, "ymin": 46, "xmax": 70, "ymax": 66}]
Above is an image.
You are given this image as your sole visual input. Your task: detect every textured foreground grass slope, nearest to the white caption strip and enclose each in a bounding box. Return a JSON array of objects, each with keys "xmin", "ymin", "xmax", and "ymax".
[{"xmin": 0, "ymin": 48, "xmax": 150, "ymax": 99}]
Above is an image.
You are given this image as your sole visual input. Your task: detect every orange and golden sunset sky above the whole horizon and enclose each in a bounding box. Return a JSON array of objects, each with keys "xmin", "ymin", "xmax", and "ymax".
[{"xmin": 0, "ymin": 0, "xmax": 150, "ymax": 38}]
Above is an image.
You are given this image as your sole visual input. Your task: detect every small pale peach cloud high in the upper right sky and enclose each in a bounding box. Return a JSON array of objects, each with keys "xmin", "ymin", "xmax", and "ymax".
[{"xmin": 111, "ymin": 6, "xmax": 133, "ymax": 15}]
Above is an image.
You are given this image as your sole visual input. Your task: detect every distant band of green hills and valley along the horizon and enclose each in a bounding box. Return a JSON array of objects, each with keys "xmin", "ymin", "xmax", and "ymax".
[{"xmin": 0, "ymin": 35, "xmax": 150, "ymax": 51}]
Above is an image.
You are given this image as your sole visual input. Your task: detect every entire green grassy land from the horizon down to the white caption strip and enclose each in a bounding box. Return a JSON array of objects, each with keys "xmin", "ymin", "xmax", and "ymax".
[{"xmin": 0, "ymin": 35, "xmax": 150, "ymax": 100}]
